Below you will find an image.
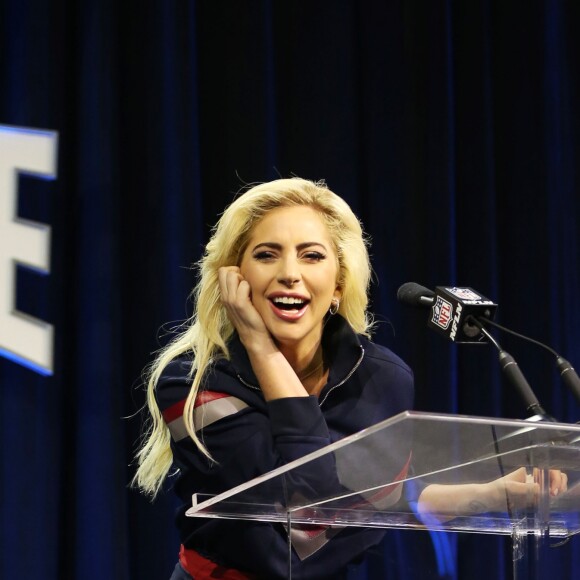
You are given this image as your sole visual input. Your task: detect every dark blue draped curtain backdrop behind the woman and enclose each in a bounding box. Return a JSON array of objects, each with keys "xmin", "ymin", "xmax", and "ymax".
[{"xmin": 0, "ymin": 0, "xmax": 580, "ymax": 580}]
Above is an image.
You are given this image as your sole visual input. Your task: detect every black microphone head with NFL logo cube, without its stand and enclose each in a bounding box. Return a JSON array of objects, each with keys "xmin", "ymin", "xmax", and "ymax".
[{"xmin": 397, "ymin": 282, "xmax": 497, "ymax": 344}]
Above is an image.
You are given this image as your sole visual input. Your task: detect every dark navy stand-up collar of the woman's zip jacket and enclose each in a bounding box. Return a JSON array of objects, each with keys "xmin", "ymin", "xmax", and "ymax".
[{"xmin": 217, "ymin": 314, "xmax": 362, "ymax": 390}]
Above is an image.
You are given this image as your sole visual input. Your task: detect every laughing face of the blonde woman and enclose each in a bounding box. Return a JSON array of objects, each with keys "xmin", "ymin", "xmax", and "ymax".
[{"xmin": 240, "ymin": 206, "xmax": 340, "ymax": 352}]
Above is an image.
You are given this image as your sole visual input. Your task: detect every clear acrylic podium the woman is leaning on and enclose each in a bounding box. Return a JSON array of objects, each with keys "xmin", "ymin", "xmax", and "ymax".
[{"xmin": 187, "ymin": 412, "xmax": 580, "ymax": 580}]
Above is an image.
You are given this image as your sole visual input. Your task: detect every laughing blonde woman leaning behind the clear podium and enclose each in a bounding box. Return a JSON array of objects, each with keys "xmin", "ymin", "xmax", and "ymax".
[{"xmin": 135, "ymin": 178, "xmax": 413, "ymax": 580}]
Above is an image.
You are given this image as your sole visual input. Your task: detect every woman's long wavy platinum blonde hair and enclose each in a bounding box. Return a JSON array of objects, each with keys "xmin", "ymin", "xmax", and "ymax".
[{"xmin": 133, "ymin": 178, "xmax": 372, "ymax": 497}]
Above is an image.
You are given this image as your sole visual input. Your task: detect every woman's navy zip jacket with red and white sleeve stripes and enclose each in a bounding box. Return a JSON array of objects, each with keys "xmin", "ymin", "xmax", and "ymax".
[{"xmin": 157, "ymin": 315, "xmax": 413, "ymax": 580}]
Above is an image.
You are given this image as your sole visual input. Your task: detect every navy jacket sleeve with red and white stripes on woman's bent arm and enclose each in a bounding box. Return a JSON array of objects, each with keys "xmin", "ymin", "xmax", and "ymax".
[{"xmin": 157, "ymin": 363, "xmax": 338, "ymax": 504}]
